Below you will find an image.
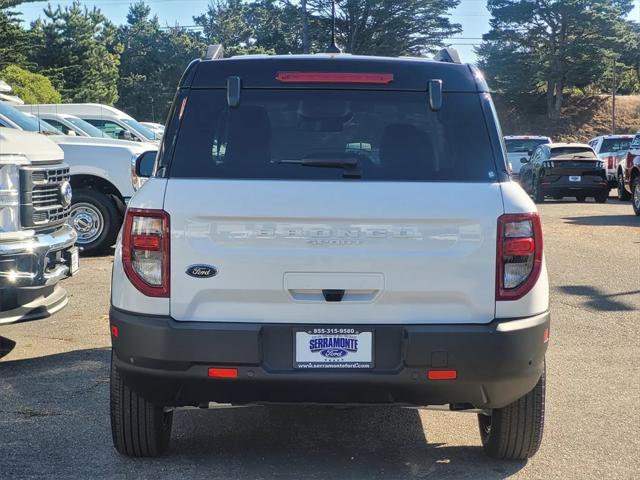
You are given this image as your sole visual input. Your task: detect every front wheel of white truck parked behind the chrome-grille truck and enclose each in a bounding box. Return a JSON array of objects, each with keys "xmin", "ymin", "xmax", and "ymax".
[{"xmin": 69, "ymin": 188, "xmax": 122, "ymax": 253}]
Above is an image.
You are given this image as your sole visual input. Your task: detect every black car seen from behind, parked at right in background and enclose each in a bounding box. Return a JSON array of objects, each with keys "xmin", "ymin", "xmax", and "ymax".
[{"xmin": 520, "ymin": 143, "xmax": 609, "ymax": 203}]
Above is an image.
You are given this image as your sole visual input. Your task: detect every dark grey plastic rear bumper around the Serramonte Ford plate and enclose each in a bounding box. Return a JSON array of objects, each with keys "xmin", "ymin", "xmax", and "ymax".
[{"xmin": 110, "ymin": 308, "xmax": 550, "ymax": 408}]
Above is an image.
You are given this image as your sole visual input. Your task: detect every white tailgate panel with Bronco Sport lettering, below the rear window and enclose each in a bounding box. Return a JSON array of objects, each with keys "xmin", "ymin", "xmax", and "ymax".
[{"xmin": 165, "ymin": 179, "xmax": 503, "ymax": 324}]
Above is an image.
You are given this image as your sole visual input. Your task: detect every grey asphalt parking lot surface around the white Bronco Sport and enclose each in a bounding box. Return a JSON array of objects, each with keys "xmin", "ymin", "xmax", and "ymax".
[{"xmin": 0, "ymin": 199, "xmax": 640, "ymax": 479}]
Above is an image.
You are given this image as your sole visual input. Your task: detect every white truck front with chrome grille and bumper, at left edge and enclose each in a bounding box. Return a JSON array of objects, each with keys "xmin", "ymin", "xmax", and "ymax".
[{"xmin": 0, "ymin": 127, "xmax": 78, "ymax": 324}]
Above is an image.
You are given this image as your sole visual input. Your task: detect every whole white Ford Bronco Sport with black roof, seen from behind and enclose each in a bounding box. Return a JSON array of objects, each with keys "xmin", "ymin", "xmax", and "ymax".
[{"xmin": 110, "ymin": 52, "xmax": 549, "ymax": 459}]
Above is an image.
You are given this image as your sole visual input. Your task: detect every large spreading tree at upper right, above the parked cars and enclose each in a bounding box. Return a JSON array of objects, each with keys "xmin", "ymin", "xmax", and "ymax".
[{"xmin": 478, "ymin": 0, "xmax": 633, "ymax": 118}]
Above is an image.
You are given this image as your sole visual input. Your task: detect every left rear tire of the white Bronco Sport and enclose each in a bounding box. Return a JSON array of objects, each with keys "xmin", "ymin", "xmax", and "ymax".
[{"xmin": 110, "ymin": 354, "xmax": 173, "ymax": 457}]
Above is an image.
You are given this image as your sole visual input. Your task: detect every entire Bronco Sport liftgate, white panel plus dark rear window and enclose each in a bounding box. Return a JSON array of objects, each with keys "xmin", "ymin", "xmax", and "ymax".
[{"xmin": 164, "ymin": 84, "xmax": 504, "ymax": 324}]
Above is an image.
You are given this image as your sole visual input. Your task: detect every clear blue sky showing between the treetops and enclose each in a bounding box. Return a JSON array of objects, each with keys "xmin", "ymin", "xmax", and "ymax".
[{"xmin": 18, "ymin": 0, "xmax": 640, "ymax": 62}]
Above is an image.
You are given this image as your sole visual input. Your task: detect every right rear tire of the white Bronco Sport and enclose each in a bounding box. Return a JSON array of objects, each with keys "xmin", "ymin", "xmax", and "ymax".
[{"xmin": 478, "ymin": 366, "xmax": 546, "ymax": 460}]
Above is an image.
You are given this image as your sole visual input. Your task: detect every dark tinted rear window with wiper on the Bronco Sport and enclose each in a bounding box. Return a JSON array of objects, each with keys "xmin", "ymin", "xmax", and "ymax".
[{"xmin": 170, "ymin": 89, "xmax": 497, "ymax": 182}]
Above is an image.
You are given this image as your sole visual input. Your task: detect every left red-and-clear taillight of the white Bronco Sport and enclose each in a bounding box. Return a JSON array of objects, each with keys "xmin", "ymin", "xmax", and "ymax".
[{"xmin": 122, "ymin": 209, "xmax": 169, "ymax": 297}]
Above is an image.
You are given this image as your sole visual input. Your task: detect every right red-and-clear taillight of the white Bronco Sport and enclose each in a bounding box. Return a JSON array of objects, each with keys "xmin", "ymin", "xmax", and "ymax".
[{"xmin": 496, "ymin": 213, "xmax": 542, "ymax": 300}]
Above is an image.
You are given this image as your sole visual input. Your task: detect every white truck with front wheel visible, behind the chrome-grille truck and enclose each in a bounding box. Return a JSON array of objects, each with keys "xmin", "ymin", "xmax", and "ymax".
[{"xmin": 0, "ymin": 102, "xmax": 158, "ymax": 253}]
